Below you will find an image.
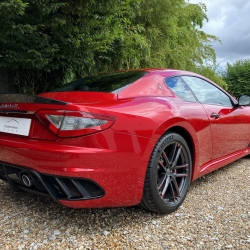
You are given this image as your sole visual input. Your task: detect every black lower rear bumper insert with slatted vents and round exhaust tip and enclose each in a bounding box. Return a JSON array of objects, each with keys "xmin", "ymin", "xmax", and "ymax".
[{"xmin": 0, "ymin": 162, "xmax": 105, "ymax": 201}]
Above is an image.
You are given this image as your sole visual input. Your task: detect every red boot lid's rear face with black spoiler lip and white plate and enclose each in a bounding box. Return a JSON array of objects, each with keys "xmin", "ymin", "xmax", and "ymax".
[{"xmin": 0, "ymin": 94, "xmax": 67, "ymax": 141}]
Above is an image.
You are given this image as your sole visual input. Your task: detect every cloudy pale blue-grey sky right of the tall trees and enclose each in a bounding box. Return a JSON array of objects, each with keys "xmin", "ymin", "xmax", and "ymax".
[{"xmin": 189, "ymin": 0, "xmax": 250, "ymax": 68}]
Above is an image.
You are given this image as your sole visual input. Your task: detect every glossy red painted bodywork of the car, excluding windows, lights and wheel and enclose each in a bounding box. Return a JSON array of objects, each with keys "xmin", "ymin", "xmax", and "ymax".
[{"xmin": 0, "ymin": 69, "xmax": 250, "ymax": 208}]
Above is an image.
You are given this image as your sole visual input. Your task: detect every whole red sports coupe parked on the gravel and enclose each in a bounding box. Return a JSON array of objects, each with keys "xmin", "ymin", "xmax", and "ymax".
[{"xmin": 0, "ymin": 69, "xmax": 250, "ymax": 213}]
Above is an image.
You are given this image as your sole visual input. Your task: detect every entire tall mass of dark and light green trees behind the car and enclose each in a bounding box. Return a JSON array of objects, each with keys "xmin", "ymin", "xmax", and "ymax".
[{"xmin": 0, "ymin": 0, "xmax": 223, "ymax": 93}]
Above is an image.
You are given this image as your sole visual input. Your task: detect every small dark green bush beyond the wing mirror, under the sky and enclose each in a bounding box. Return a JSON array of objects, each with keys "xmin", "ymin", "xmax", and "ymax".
[{"xmin": 224, "ymin": 59, "xmax": 250, "ymax": 96}]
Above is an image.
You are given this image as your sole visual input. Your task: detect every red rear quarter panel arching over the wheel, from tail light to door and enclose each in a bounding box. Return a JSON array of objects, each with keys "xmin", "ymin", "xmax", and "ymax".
[{"xmin": 68, "ymin": 96, "xmax": 212, "ymax": 182}]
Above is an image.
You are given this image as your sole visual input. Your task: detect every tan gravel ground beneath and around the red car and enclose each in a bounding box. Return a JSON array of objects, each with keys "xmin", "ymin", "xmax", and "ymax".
[{"xmin": 0, "ymin": 158, "xmax": 250, "ymax": 250}]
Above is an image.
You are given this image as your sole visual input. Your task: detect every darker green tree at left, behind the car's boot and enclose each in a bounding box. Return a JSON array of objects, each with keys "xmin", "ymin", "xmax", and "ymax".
[{"xmin": 0, "ymin": 0, "xmax": 141, "ymax": 94}]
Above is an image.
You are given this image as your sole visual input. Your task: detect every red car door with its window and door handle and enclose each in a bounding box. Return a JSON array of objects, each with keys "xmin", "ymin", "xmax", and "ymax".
[{"xmin": 182, "ymin": 76, "xmax": 250, "ymax": 159}]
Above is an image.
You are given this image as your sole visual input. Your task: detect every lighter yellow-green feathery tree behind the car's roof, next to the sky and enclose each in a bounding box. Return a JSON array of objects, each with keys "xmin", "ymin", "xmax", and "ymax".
[{"xmin": 92, "ymin": 0, "xmax": 219, "ymax": 70}]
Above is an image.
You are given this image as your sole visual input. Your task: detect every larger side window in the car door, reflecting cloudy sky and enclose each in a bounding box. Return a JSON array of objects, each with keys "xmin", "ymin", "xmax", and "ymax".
[{"xmin": 182, "ymin": 76, "xmax": 232, "ymax": 107}]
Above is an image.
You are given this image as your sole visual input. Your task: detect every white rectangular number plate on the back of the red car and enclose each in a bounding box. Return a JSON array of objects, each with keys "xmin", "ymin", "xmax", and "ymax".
[{"xmin": 0, "ymin": 116, "xmax": 31, "ymax": 136}]
